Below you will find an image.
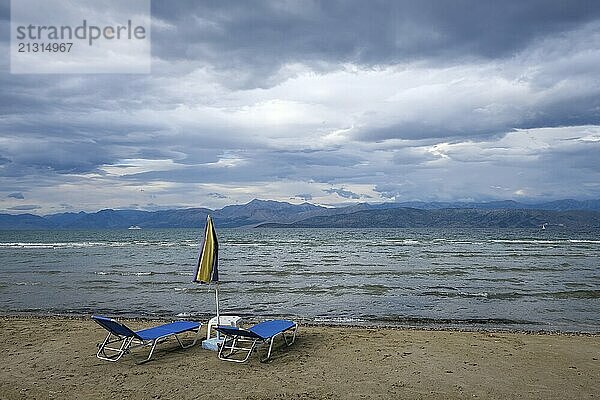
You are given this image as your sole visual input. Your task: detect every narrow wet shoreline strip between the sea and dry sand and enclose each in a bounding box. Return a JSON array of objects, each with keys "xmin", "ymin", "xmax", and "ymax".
[{"xmin": 0, "ymin": 312, "xmax": 600, "ymax": 336}]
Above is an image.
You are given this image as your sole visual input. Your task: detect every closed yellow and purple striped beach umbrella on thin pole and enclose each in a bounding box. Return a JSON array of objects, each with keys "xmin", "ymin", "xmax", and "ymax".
[{"xmin": 194, "ymin": 215, "xmax": 219, "ymax": 324}]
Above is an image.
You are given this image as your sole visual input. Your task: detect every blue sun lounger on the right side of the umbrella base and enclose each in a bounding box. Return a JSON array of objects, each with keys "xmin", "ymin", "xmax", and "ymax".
[{"xmin": 215, "ymin": 319, "xmax": 298, "ymax": 363}]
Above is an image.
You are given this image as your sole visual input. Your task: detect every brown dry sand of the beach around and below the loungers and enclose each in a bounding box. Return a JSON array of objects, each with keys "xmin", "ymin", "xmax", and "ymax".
[{"xmin": 0, "ymin": 317, "xmax": 600, "ymax": 399}]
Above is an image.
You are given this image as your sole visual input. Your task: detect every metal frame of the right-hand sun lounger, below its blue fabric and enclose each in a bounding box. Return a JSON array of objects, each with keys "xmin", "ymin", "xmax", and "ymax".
[{"xmin": 215, "ymin": 323, "xmax": 298, "ymax": 363}]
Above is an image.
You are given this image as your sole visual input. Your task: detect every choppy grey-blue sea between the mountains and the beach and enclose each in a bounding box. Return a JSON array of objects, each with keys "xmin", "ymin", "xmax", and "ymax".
[{"xmin": 0, "ymin": 227, "xmax": 600, "ymax": 333}]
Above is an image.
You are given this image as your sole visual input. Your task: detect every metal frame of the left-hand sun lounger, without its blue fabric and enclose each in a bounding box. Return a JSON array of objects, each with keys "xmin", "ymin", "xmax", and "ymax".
[{"xmin": 92, "ymin": 316, "xmax": 202, "ymax": 364}]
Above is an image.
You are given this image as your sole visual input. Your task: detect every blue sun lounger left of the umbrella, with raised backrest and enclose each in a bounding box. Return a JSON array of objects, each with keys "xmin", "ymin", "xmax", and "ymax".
[{"xmin": 92, "ymin": 315, "xmax": 201, "ymax": 362}]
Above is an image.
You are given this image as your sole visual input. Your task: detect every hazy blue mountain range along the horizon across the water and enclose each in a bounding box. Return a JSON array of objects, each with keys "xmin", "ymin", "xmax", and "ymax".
[{"xmin": 0, "ymin": 199, "xmax": 600, "ymax": 230}]
